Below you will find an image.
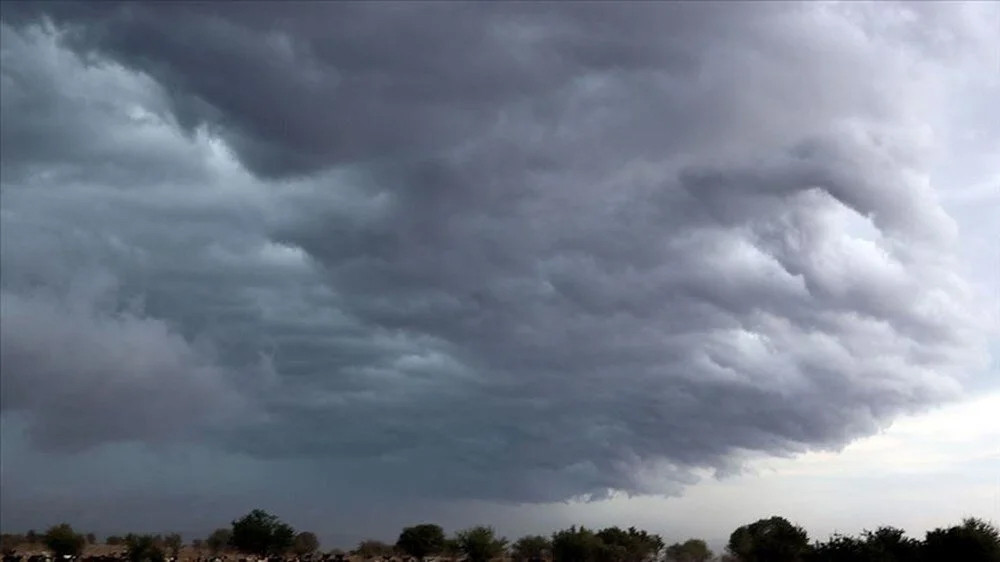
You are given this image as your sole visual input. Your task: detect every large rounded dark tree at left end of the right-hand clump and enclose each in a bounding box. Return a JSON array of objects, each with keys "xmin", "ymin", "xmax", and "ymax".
[{"xmin": 727, "ymin": 516, "xmax": 809, "ymax": 562}]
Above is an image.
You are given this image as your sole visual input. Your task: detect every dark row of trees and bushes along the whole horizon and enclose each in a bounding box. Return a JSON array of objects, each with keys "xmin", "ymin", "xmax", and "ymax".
[{"xmin": 0, "ymin": 509, "xmax": 1000, "ymax": 562}]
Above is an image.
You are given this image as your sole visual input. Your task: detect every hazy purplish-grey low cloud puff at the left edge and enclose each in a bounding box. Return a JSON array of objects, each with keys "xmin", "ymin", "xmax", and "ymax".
[{"xmin": 0, "ymin": 274, "xmax": 249, "ymax": 449}]
